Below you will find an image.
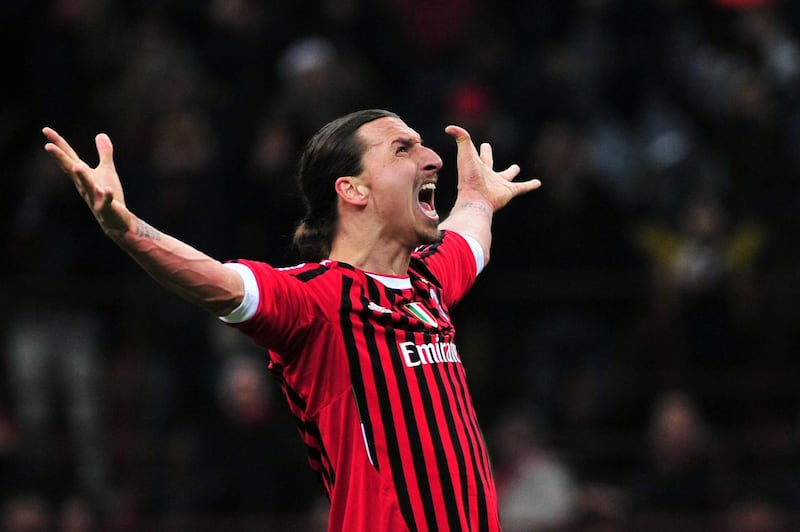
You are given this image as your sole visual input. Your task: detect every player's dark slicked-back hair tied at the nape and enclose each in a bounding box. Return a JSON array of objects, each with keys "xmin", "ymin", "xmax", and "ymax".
[{"xmin": 293, "ymin": 109, "xmax": 398, "ymax": 261}]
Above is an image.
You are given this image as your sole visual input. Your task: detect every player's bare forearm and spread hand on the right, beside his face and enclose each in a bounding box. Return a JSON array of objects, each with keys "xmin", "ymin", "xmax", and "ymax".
[{"xmin": 439, "ymin": 126, "xmax": 542, "ymax": 262}]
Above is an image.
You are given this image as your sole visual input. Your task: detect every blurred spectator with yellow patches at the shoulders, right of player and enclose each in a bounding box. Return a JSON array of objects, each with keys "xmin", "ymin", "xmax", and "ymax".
[{"xmin": 636, "ymin": 193, "xmax": 766, "ymax": 375}]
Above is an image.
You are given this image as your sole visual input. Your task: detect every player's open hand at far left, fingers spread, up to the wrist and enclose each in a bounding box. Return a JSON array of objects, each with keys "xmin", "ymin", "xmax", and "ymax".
[{"xmin": 42, "ymin": 127, "xmax": 133, "ymax": 236}]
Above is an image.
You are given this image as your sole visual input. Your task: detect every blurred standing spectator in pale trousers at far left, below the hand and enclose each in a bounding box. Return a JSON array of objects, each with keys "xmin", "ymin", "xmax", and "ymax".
[{"xmin": 4, "ymin": 150, "xmax": 114, "ymax": 511}]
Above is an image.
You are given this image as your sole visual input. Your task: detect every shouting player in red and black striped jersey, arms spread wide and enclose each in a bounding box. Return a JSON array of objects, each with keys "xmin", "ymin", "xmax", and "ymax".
[{"xmin": 43, "ymin": 110, "xmax": 540, "ymax": 531}]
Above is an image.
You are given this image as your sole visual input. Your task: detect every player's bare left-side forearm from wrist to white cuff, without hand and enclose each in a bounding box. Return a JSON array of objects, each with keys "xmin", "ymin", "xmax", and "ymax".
[{"xmin": 107, "ymin": 215, "xmax": 244, "ymax": 316}]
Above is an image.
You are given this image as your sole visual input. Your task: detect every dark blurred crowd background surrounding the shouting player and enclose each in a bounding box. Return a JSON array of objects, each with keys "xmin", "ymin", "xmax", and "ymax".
[{"xmin": 0, "ymin": 0, "xmax": 800, "ymax": 532}]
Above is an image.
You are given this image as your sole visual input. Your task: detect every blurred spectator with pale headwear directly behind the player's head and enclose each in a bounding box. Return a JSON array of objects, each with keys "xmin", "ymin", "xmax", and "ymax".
[{"xmin": 231, "ymin": 35, "xmax": 372, "ymax": 264}]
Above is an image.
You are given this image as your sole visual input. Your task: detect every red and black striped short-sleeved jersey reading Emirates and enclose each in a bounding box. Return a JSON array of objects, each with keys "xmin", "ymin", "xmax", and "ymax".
[{"xmin": 225, "ymin": 232, "xmax": 500, "ymax": 531}]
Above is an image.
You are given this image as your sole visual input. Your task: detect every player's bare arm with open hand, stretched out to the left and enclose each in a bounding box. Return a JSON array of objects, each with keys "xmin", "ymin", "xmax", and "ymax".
[{"xmin": 42, "ymin": 128, "xmax": 244, "ymax": 316}]
